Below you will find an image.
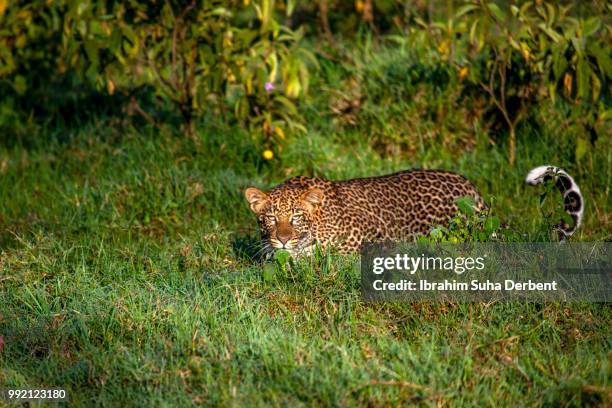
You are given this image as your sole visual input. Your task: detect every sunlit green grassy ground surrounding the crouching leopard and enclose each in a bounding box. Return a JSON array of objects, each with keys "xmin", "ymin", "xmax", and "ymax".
[{"xmin": 0, "ymin": 47, "xmax": 612, "ymax": 406}]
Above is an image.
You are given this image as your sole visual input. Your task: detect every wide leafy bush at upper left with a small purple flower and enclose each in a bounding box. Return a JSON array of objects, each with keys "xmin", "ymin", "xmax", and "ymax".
[{"xmin": 0, "ymin": 0, "xmax": 316, "ymax": 145}]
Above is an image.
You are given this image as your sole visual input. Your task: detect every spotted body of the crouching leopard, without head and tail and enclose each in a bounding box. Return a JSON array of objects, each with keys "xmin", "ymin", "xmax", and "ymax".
[{"xmin": 317, "ymin": 170, "xmax": 484, "ymax": 251}]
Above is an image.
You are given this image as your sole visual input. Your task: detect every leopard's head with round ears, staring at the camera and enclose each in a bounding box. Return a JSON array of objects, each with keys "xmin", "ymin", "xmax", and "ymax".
[{"xmin": 244, "ymin": 186, "xmax": 323, "ymax": 255}]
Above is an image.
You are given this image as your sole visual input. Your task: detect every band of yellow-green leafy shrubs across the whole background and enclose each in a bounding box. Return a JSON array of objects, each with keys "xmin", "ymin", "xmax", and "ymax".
[{"xmin": 0, "ymin": 0, "xmax": 612, "ymax": 159}]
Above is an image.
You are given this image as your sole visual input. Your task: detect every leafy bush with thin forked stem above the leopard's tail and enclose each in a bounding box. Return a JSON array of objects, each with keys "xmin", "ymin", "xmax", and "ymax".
[{"xmin": 414, "ymin": 1, "xmax": 611, "ymax": 164}]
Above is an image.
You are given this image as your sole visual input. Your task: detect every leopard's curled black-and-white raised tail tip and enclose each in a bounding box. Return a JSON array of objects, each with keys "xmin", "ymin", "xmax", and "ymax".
[{"xmin": 525, "ymin": 166, "xmax": 584, "ymax": 239}]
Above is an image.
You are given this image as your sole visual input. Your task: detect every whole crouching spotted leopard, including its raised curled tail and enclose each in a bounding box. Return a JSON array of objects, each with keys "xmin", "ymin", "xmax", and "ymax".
[{"xmin": 244, "ymin": 165, "xmax": 584, "ymax": 256}]
